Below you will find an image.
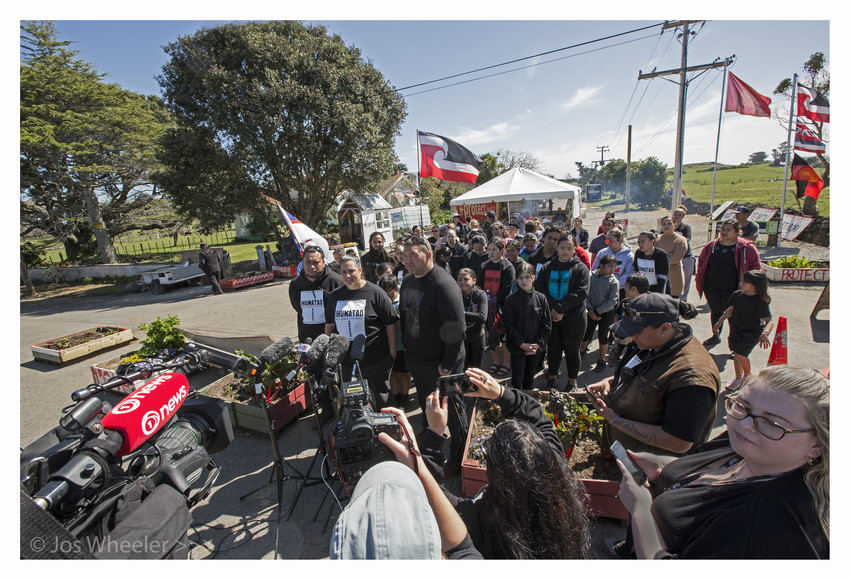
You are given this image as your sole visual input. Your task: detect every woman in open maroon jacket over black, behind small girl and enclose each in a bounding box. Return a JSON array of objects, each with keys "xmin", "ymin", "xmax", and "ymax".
[{"xmin": 696, "ymin": 220, "xmax": 761, "ymax": 347}]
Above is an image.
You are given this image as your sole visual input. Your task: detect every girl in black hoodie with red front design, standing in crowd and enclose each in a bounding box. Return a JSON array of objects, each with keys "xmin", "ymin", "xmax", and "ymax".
[{"xmin": 478, "ymin": 237, "xmax": 516, "ymax": 378}]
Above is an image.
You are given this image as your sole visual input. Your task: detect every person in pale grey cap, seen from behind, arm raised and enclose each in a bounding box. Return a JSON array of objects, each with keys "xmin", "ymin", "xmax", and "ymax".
[{"xmin": 330, "ymin": 420, "xmax": 481, "ymax": 560}]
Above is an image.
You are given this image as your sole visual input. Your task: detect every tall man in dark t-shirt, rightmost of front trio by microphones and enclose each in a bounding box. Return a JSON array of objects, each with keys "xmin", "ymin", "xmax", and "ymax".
[{"xmin": 399, "ymin": 236, "xmax": 466, "ymax": 477}]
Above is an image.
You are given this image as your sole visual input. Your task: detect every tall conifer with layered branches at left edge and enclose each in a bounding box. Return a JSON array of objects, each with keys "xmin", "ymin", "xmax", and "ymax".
[{"xmin": 21, "ymin": 22, "xmax": 166, "ymax": 264}]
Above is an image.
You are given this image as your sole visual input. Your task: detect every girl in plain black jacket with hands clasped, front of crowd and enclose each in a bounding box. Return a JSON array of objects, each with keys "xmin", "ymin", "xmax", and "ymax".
[{"xmin": 502, "ymin": 261, "xmax": 552, "ymax": 390}]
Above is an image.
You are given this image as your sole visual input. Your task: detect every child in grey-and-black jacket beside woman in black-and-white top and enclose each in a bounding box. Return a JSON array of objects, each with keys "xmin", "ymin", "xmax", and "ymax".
[{"xmin": 581, "ymin": 254, "xmax": 620, "ymax": 373}]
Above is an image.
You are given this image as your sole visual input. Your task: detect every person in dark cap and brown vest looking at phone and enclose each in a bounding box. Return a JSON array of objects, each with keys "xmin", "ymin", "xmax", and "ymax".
[{"xmin": 588, "ymin": 292, "xmax": 720, "ymax": 455}]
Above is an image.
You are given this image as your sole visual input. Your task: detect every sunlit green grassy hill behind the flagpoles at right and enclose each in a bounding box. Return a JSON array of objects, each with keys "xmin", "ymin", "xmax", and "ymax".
[{"xmin": 668, "ymin": 162, "xmax": 830, "ymax": 216}]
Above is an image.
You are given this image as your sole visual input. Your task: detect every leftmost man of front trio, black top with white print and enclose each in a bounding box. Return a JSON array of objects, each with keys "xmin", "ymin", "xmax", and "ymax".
[{"xmin": 289, "ymin": 246, "xmax": 343, "ymax": 342}]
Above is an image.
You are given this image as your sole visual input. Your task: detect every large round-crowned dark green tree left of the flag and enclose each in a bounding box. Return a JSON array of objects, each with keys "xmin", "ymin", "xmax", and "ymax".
[{"xmin": 157, "ymin": 22, "xmax": 406, "ymax": 226}]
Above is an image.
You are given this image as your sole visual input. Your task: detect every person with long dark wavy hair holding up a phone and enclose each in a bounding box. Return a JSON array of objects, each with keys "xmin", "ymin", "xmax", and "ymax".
[{"xmin": 412, "ymin": 369, "xmax": 590, "ymax": 559}]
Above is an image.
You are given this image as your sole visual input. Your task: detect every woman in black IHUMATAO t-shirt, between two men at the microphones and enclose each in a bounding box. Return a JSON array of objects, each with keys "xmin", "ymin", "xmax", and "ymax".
[{"xmin": 325, "ymin": 255, "xmax": 398, "ymax": 409}]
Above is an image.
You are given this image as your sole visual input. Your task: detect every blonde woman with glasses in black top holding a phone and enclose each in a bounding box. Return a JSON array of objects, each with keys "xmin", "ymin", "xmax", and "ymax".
[{"xmin": 615, "ymin": 366, "xmax": 829, "ymax": 560}]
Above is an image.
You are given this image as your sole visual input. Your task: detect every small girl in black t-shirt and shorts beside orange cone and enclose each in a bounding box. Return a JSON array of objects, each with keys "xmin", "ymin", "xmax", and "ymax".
[{"xmin": 714, "ymin": 270, "xmax": 773, "ymax": 391}]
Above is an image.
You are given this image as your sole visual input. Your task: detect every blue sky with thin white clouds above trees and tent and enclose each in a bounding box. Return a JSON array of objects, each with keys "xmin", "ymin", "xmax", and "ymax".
[{"xmin": 39, "ymin": 18, "xmax": 829, "ymax": 178}]
